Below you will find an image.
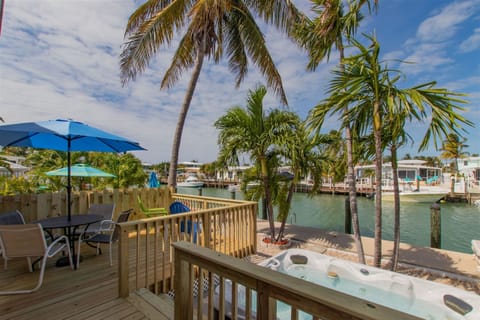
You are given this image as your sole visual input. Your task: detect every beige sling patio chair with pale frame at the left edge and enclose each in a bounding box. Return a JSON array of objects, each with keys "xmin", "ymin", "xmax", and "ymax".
[{"xmin": 0, "ymin": 223, "xmax": 73, "ymax": 295}]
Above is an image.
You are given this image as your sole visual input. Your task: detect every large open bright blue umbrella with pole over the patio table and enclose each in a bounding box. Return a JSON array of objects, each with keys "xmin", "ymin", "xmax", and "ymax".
[{"xmin": 0, "ymin": 119, "xmax": 145, "ymax": 220}]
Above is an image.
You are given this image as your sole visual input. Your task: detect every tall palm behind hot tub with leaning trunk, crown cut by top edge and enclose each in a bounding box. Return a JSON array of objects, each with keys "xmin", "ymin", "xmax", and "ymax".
[{"xmin": 296, "ymin": 0, "xmax": 377, "ymax": 263}]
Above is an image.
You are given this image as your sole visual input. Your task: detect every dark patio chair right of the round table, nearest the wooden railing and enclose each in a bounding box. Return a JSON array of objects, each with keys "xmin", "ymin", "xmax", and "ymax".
[{"xmin": 77, "ymin": 209, "xmax": 133, "ymax": 268}]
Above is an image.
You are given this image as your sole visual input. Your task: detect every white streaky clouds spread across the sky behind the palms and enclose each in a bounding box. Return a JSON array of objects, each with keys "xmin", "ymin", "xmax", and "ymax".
[{"xmin": 0, "ymin": 0, "xmax": 480, "ymax": 163}]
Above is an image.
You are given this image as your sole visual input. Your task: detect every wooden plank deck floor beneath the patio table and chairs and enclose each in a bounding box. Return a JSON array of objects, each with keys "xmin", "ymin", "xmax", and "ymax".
[{"xmin": 0, "ymin": 242, "xmax": 154, "ymax": 320}]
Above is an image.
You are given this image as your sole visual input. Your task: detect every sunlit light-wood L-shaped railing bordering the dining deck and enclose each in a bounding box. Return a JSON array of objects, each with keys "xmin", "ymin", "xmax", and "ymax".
[{"xmin": 119, "ymin": 194, "xmax": 258, "ymax": 297}]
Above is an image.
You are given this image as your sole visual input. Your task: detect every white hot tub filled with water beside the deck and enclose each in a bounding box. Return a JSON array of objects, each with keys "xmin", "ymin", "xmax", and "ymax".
[{"xmin": 261, "ymin": 249, "xmax": 480, "ymax": 320}]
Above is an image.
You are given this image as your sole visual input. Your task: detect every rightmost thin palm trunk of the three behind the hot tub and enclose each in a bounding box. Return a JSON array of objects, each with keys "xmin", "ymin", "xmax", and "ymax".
[{"xmin": 390, "ymin": 145, "xmax": 400, "ymax": 271}]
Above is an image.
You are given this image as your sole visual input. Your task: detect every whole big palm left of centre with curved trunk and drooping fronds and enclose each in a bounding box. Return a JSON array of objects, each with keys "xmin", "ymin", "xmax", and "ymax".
[{"xmin": 120, "ymin": 0, "xmax": 300, "ymax": 188}]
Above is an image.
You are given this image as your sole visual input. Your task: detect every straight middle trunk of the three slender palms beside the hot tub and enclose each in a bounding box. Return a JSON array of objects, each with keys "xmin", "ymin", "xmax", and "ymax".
[{"xmin": 373, "ymin": 101, "xmax": 382, "ymax": 267}]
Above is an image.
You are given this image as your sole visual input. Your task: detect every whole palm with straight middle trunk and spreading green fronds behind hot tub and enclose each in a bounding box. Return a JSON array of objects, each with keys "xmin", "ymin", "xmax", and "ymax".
[{"xmin": 316, "ymin": 37, "xmax": 473, "ymax": 266}]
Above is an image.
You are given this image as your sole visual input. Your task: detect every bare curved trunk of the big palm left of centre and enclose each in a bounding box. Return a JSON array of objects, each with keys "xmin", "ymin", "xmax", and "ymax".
[{"xmin": 168, "ymin": 38, "xmax": 206, "ymax": 190}]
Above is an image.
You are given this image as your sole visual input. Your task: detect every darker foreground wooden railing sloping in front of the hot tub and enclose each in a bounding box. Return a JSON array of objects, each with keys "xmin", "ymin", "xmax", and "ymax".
[{"xmin": 173, "ymin": 242, "xmax": 419, "ymax": 320}]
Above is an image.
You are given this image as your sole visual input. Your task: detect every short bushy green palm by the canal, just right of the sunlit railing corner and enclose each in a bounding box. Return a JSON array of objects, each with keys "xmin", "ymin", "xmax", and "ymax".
[{"xmin": 215, "ymin": 86, "xmax": 298, "ymax": 241}]
